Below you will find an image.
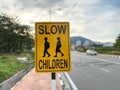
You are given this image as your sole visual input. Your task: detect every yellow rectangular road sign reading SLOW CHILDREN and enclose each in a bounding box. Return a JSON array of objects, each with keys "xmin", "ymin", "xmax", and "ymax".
[{"xmin": 35, "ymin": 22, "xmax": 71, "ymax": 72}]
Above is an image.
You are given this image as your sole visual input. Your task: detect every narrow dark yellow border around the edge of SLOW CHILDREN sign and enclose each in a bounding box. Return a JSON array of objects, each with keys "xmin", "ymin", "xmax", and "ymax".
[{"xmin": 35, "ymin": 22, "xmax": 71, "ymax": 72}]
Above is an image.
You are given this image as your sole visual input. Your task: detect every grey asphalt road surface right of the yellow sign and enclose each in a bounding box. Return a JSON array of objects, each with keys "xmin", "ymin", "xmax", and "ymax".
[{"xmin": 68, "ymin": 51, "xmax": 120, "ymax": 90}]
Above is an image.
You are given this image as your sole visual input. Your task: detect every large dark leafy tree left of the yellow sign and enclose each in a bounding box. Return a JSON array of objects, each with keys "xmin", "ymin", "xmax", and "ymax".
[{"xmin": 0, "ymin": 14, "xmax": 33, "ymax": 53}]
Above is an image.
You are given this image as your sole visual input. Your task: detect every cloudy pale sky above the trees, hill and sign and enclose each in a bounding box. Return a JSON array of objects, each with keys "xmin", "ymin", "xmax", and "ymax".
[{"xmin": 0, "ymin": 0, "xmax": 120, "ymax": 42}]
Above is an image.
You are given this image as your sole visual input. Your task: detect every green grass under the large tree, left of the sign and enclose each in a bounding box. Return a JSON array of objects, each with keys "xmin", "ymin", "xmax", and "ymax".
[{"xmin": 0, "ymin": 53, "xmax": 32, "ymax": 83}]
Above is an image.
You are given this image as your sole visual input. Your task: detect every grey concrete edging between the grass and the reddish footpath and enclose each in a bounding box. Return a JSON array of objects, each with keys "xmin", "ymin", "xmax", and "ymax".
[{"xmin": 0, "ymin": 61, "xmax": 34, "ymax": 90}]
